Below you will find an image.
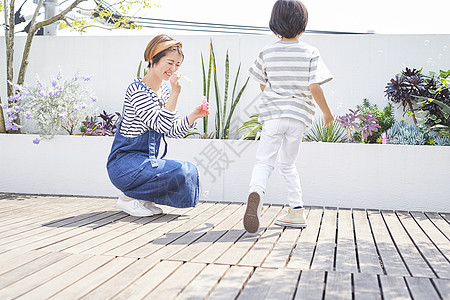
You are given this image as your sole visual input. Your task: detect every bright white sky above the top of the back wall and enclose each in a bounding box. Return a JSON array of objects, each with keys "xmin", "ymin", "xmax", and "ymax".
[{"xmin": 0, "ymin": 0, "xmax": 450, "ymax": 35}]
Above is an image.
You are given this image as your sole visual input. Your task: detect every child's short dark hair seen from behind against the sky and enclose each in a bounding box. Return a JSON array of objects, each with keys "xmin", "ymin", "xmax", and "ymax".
[{"xmin": 269, "ymin": 0, "xmax": 308, "ymax": 39}]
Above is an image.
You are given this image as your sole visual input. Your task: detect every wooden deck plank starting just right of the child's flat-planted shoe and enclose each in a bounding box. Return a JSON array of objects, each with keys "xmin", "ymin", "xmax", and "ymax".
[{"xmin": 287, "ymin": 207, "xmax": 323, "ymax": 270}]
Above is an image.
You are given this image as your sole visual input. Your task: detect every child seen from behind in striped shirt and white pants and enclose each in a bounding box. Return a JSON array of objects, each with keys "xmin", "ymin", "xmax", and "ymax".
[{"xmin": 244, "ymin": 0, "xmax": 334, "ymax": 233}]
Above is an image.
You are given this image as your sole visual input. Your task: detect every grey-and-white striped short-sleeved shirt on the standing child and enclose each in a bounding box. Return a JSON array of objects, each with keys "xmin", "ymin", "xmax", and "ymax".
[{"xmin": 249, "ymin": 41, "xmax": 333, "ymax": 127}]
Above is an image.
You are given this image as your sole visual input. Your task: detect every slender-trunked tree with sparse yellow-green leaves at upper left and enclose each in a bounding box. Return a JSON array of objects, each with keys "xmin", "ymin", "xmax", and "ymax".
[{"xmin": 0, "ymin": 0, "xmax": 151, "ymax": 133}]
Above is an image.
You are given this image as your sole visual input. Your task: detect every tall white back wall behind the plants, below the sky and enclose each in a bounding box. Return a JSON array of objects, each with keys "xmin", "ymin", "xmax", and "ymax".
[{"xmin": 0, "ymin": 34, "xmax": 450, "ymax": 136}]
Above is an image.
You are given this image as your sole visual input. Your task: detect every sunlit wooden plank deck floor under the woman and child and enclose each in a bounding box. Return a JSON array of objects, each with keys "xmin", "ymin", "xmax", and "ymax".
[{"xmin": 0, "ymin": 194, "xmax": 450, "ymax": 300}]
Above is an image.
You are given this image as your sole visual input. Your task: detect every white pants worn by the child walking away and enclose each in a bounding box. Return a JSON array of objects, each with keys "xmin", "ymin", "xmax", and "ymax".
[{"xmin": 250, "ymin": 118, "xmax": 306, "ymax": 207}]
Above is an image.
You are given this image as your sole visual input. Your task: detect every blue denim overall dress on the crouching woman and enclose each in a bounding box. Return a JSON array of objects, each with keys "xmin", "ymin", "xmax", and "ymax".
[{"xmin": 107, "ymin": 82, "xmax": 199, "ymax": 208}]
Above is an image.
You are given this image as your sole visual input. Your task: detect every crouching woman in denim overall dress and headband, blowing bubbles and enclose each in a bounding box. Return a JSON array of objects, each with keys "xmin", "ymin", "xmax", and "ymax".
[{"xmin": 107, "ymin": 35, "xmax": 209, "ymax": 217}]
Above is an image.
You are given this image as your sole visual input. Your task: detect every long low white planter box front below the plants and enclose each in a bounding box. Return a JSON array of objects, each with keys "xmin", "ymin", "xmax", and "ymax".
[{"xmin": 0, "ymin": 134, "xmax": 450, "ymax": 212}]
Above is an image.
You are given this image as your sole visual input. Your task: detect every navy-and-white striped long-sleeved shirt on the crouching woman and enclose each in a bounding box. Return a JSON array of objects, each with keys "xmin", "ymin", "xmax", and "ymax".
[{"xmin": 120, "ymin": 78, "xmax": 191, "ymax": 138}]
